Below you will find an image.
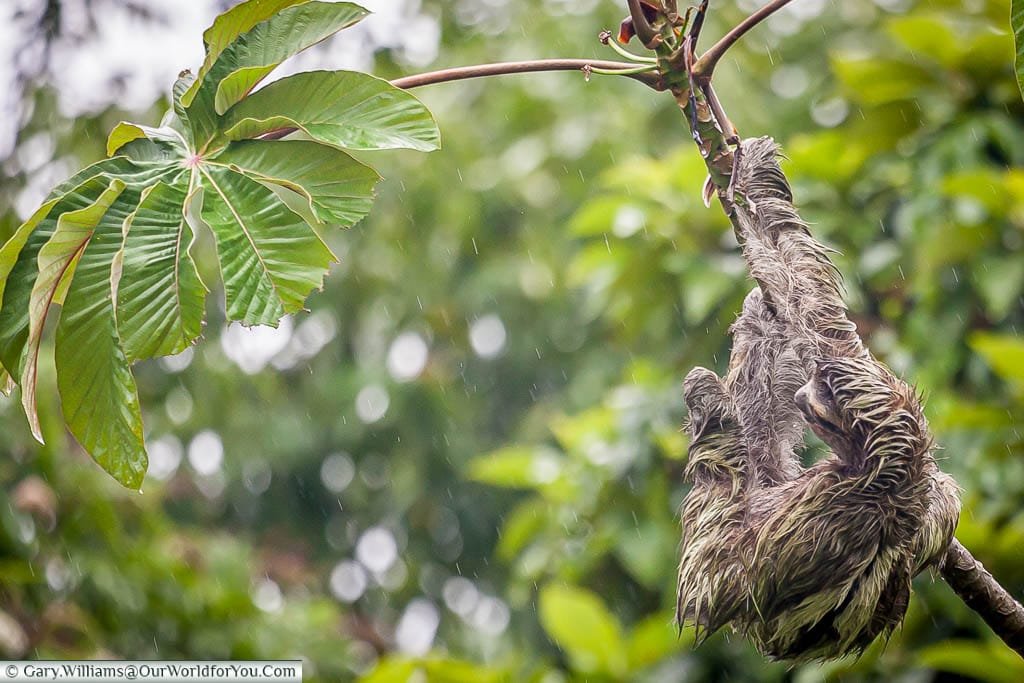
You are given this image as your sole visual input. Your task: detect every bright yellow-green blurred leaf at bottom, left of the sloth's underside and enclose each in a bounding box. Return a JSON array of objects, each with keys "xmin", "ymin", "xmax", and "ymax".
[{"xmin": 540, "ymin": 584, "xmax": 627, "ymax": 676}]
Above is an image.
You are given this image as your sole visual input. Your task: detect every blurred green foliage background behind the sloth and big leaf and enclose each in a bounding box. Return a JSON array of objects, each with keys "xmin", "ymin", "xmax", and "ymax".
[{"xmin": 0, "ymin": 0, "xmax": 1024, "ymax": 683}]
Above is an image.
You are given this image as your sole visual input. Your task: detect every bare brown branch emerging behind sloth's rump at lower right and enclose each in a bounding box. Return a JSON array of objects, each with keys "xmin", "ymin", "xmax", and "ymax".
[{"xmin": 939, "ymin": 539, "xmax": 1024, "ymax": 656}]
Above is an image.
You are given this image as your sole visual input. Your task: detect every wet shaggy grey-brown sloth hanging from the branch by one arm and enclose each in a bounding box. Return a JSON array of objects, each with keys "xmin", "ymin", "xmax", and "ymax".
[{"xmin": 677, "ymin": 138, "xmax": 959, "ymax": 660}]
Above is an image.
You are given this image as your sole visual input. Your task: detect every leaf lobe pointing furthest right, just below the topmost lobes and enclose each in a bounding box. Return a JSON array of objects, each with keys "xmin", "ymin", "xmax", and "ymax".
[{"xmin": 223, "ymin": 71, "xmax": 440, "ymax": 152}]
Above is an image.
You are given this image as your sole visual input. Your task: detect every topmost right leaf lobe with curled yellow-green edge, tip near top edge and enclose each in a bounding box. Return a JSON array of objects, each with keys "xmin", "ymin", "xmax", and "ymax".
[{"xmin": 214, "ymin": 2, "xmax": 368, "ymax": 114}]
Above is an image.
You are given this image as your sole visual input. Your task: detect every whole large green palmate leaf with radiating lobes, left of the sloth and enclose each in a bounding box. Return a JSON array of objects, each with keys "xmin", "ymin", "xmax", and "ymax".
[{"xmin": 0, "ymin": 0, "xmax": 438, "ymax": 487}]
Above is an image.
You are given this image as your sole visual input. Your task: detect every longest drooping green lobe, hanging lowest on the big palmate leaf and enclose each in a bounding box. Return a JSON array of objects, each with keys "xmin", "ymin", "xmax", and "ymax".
[{"xmin": 54, "ymin": 192, "xmax": 148, "ymax": 488}]
